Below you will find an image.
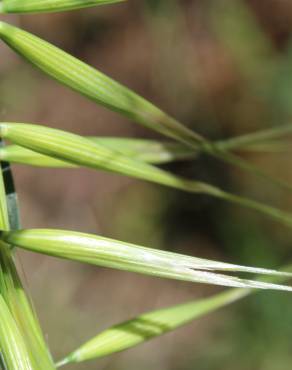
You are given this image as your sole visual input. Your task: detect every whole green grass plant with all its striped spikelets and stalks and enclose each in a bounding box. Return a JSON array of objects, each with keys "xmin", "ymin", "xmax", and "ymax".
[{"xmin": 0, "ymin": 0, "xmax": 292, "ymax": 370}]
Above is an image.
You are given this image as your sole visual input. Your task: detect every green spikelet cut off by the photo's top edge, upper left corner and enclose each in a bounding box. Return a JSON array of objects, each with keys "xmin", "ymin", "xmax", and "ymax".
[{"xmin": 0, "ymin": 0, "xmax": 125, "ymax": 13}]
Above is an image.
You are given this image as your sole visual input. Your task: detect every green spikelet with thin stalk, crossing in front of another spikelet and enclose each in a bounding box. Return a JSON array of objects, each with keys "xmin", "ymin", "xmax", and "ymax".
[{"xmin": 0, "ymin": 122, "xmax": 292, "ymax": 227}]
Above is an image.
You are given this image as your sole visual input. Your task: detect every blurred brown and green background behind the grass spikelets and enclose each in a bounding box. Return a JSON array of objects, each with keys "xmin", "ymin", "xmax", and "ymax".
[{"xmin": 0, "ymin": 0, "xmax": 292, "ymax": 370}]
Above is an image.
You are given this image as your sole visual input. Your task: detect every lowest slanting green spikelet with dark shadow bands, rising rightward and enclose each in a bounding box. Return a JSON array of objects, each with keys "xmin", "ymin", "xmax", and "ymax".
[{"xmin": 57, "ymin": 266, "xmax": 291, "ymax": 367}]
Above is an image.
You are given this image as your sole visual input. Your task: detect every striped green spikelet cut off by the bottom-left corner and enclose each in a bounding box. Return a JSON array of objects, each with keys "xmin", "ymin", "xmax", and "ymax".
[{"xmin": 0, "ymin": 295, "xmax": 34, "ymax": 370}]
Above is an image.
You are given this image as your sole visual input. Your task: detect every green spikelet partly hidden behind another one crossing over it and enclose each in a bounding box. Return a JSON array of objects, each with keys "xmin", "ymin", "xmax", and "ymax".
[{"xmin": 0, "ymin": 125, "xmax": 292, "ymax": 168}]
